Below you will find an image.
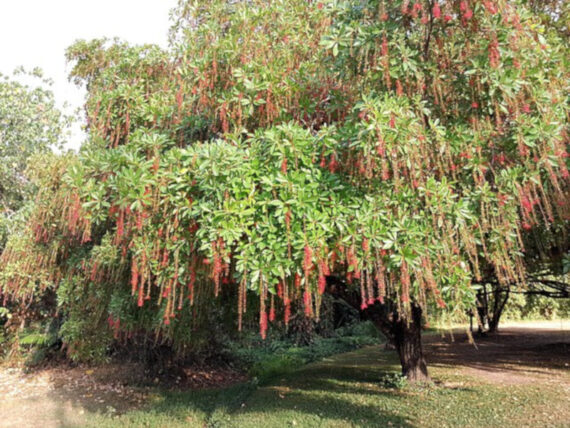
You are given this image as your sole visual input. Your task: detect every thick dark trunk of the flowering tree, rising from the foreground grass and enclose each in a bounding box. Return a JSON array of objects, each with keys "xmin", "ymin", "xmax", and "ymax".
[{"xmin": 392, "ymin": 305, "xmax": 430, "ymax": 382}]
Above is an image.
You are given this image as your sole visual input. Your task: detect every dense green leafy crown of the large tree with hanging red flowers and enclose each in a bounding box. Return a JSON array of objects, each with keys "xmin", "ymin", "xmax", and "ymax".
[{"xmin": 2, "ymin": 0, "xmax": 570, "ymax": 352}]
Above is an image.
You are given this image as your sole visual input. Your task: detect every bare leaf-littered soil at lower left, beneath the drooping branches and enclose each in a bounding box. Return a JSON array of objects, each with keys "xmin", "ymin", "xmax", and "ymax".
[{"xmin": 0, "ymin": 364, "xmax": 247, "ymax": 428}]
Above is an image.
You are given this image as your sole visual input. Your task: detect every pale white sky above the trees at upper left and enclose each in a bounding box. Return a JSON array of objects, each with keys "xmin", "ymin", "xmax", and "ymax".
[{"xmin": 0, "ymin": 0, "xmax": 177, "ymax": 149}]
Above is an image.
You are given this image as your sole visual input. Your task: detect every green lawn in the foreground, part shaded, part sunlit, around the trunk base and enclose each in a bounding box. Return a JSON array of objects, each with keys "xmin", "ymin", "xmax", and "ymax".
[{"xmin": 77, "ymin": 346, "xmax": 568, "ymax": 428}]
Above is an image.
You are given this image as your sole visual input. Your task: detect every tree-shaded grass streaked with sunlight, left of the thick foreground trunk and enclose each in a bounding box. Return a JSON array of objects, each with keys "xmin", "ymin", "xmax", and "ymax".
[{"xmin": 45, "ymin": 348, "xmax": 414, "ymax": 428}]
